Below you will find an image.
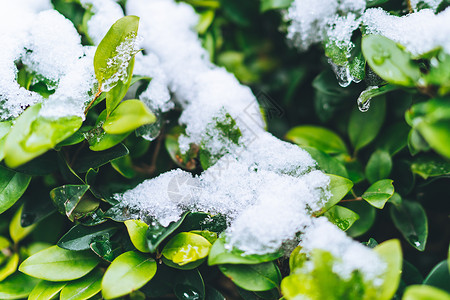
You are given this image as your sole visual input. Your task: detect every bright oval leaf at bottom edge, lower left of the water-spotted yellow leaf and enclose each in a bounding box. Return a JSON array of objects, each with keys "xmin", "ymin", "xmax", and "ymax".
[{"xmin": 102, "ymin": 251, "xmax": 156, "ymax": 299}]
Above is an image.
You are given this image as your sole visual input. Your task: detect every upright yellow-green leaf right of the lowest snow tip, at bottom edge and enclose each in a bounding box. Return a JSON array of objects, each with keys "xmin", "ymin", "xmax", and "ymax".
[{"xmin": 374, "ymin": 240, "xmax": 402, "ymax": 300}]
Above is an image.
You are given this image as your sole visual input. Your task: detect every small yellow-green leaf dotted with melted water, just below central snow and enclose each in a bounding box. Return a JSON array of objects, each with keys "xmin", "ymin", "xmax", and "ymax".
[{"xmin": 162, "ymin": 232, "xmax": 211, "ymax": 266}]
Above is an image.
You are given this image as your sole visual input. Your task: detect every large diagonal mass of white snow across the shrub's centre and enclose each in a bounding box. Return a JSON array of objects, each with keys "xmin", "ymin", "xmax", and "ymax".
[{"xmin": 109, "ymin": 0, "xmax": 384, "ymax": 279}]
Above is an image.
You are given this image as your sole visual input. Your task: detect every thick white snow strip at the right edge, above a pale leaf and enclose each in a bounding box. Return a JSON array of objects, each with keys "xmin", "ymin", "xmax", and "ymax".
[{"xmin": 363, "ymin": 8, "xmax": 450, "ymax": 55}]
